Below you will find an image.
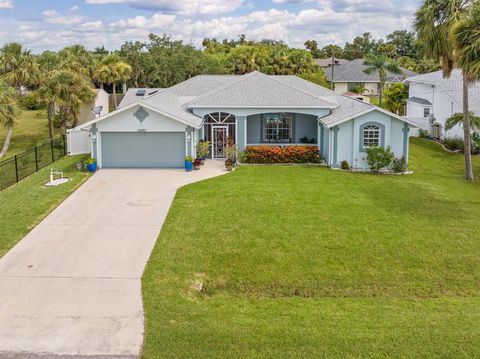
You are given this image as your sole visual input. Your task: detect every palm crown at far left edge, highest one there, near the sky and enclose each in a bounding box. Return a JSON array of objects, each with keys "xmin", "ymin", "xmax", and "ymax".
[{"xmin": 0, "ymin": 42, "xmax": 38, "ymax": 94}]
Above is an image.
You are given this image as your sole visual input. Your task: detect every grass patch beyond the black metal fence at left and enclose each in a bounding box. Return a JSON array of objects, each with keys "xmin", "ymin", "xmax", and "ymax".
[{"xmin": 0, "ymin": 108, "xmax": 59, "ymax": 161}]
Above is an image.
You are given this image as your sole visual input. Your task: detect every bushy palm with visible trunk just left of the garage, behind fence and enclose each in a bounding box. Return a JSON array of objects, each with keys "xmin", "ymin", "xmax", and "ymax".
[{"xmin": 38, "ymin": 70, "xmax": 95, "ymax": 138}]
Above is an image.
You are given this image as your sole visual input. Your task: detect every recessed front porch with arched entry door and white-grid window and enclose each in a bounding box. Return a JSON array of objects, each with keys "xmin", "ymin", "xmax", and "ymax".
[{"xmin": 199, "ymin": 111, "xmax": 324, "ymax": 158}]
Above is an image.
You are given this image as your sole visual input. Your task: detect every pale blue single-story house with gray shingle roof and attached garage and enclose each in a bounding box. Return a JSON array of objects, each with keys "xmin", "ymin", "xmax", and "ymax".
[{"xmin": 70, "ymin": 72, "xmax": 414, "ymax": 172}]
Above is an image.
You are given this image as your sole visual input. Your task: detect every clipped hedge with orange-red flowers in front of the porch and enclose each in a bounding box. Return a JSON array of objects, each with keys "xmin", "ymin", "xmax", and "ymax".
[{"xmin": 243, "ymin": 146, "xmax": 320, "ymax": 164}]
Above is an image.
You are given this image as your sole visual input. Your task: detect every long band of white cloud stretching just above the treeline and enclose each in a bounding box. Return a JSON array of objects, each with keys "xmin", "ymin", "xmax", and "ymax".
[{"xmin": 0, "ymin": 0, "xmax": 419, "ymax": 51}]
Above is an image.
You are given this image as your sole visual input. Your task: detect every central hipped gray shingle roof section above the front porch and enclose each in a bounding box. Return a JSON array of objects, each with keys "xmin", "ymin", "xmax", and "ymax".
[{"xmin": 188, "ymin": 71, "xmax": 337, "ymax": 108}]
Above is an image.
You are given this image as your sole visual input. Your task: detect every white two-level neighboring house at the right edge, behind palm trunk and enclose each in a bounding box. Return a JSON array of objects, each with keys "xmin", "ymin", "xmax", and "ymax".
[{"xmin": 405, "ymin": 69, "xmax": 480, "ymax": 138}]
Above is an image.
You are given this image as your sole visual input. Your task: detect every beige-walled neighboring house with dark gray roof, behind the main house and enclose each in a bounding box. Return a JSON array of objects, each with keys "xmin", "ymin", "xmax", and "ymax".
[{"xmin": 325, "ymin": 59, "xmax": 416, "ymax": 96}]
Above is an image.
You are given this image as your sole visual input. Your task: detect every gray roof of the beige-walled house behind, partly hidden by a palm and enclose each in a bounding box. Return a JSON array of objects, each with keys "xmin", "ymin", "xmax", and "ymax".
[{"xmin": 325, "ymin": 59, "xmax": 416, "ymax": 82}]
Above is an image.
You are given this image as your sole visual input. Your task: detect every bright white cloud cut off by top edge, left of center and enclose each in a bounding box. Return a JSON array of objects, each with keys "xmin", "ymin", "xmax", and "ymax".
[{"xmin": 86, "ymin": 0, "xmax": 243, "ymax": 16}]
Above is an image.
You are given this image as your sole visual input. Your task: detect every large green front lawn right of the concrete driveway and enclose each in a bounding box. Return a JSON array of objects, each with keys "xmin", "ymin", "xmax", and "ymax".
[{"xmin": 143, "ymin": 139, "xmax": 480, "ymax": 359}]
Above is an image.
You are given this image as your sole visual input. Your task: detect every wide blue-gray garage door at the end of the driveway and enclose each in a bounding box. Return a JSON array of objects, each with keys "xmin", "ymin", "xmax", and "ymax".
[{"xmin": 101, "ymin": 132, "xmax": 185, "ymax": 168}]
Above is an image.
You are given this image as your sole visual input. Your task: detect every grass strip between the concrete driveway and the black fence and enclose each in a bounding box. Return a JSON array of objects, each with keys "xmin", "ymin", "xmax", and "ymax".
[{"xmin": 0, "ymin": 156, "xmax": 89, "ymax": 257}]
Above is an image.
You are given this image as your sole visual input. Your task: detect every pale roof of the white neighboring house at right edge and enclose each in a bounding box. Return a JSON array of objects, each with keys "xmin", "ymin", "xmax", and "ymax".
[{"xmin": 405, "ymin": 69, "xmax": 480, "ymax": 115}]
